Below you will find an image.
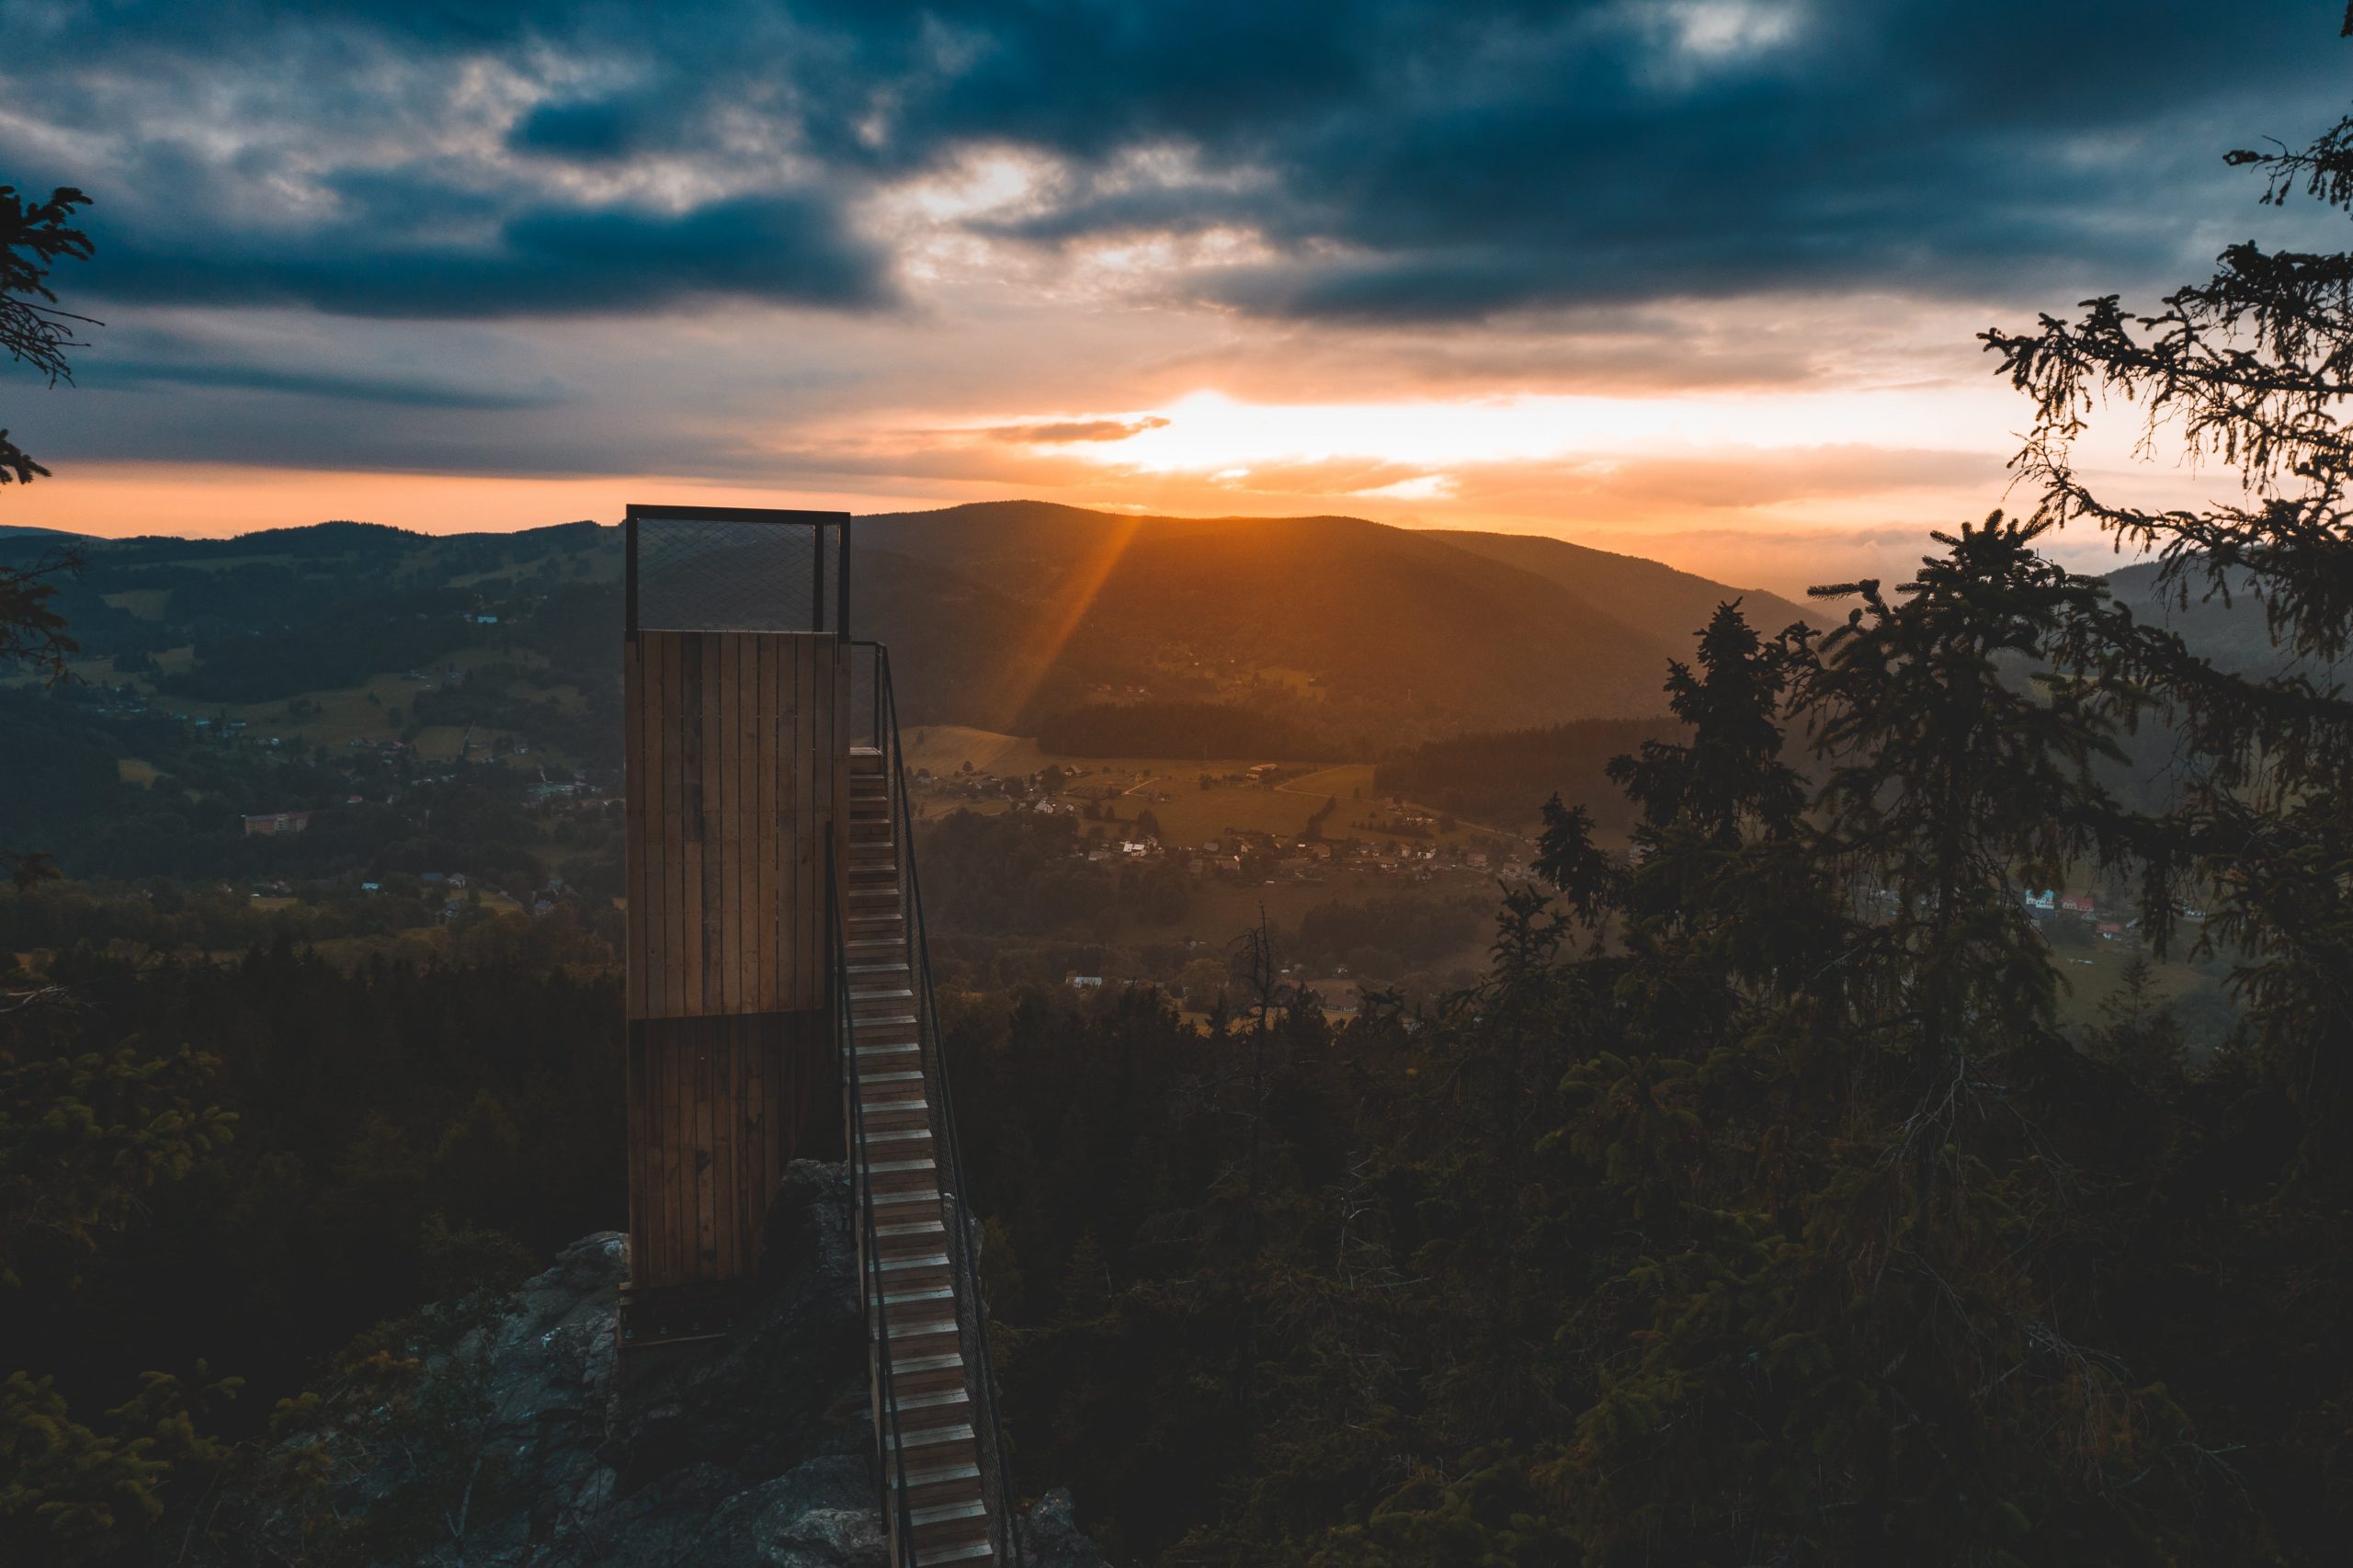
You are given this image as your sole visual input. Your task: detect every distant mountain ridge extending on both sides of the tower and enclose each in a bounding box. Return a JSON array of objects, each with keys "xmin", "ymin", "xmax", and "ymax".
[{"xmin": 0, "ymin": 502, "xmax": 1802, "ymax": 756}]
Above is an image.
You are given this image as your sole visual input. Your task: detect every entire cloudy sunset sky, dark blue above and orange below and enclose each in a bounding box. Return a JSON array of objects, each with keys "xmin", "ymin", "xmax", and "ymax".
[{"xmin": 0, "ymin": 0, "xmax": 2353, "ymax": 586}]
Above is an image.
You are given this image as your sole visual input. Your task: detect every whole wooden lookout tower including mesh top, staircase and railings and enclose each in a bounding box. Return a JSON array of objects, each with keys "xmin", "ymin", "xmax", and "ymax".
[{"xmin": 621, "ymin": 506, "xmax": 1018, "ymax": 1568}]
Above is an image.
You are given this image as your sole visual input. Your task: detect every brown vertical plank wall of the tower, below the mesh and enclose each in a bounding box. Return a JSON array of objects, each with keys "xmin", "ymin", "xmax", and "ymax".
[{"xmin": 623, "ymin": 631, "xmax": 849, "ymax": 1288}]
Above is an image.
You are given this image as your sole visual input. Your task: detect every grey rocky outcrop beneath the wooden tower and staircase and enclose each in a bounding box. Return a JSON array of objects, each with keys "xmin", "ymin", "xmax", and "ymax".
[{"xmin": 243, "ymin": 1161, "xmax": 1104, "ymax": 1568}]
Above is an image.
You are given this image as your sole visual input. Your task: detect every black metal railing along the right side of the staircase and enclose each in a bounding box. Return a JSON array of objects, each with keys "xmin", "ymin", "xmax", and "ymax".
[{"xmin": 840, "ymin": 638, "xmax": 1021, "ymax": 1563}]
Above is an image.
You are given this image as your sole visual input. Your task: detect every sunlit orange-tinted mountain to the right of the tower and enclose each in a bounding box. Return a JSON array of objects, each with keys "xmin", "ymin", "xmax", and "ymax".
[{"xmin": 852, "ymin": 502, "xmax": 1802, "ymax": 756}]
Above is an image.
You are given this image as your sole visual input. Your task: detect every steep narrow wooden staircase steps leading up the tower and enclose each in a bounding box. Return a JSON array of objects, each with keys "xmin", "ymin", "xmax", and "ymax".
[{"xmin": 840, "ymin": 746, "xmax": 995, "ymax": 1568}]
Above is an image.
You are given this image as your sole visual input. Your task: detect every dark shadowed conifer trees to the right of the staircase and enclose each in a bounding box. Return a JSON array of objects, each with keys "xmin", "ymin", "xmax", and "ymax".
[{"xmin": 958, "ymin": 518, "xmax": 2325, "ymax": 1565}]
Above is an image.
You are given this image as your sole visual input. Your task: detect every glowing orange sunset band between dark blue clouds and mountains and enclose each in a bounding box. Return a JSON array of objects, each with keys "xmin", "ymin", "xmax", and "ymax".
[{"xmin": 0, "ymin": 283, "xmax": 2183, "ymax": 591}]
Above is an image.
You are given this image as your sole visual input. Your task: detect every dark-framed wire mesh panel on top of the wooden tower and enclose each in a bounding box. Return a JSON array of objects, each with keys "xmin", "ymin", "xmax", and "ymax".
[{"xmin": 626, "ymin": 506, "xmax": 849, "ymax": 633}]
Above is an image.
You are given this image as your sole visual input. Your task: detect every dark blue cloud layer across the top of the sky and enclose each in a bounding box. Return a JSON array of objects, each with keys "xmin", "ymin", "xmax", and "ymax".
[{"xmin": 0, "ymin": 0, "xmax": 2344, "ymax": 320}]
